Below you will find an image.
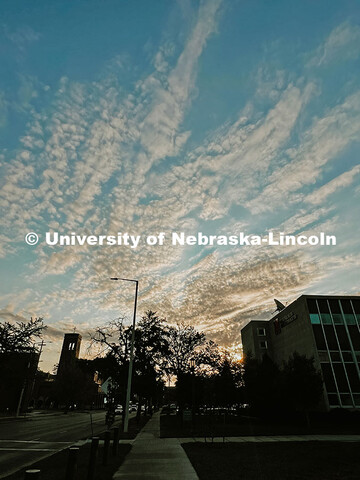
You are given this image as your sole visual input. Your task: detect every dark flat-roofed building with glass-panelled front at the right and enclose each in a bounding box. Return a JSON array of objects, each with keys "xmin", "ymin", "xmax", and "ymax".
[{"xmin": 241, "ymin": 295, "xmax": 360, "ymax": 410}]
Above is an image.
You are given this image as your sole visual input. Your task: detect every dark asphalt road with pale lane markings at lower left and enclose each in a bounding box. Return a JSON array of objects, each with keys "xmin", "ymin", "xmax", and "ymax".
[{"xmin": 0, "ymin": 411, "xmax": 112, "ymax": 478}]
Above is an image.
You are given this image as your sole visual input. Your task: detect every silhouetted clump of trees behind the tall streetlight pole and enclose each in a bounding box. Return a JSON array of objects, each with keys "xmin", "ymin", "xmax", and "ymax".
[{"xmin": 88, "ymin": 310, "xmax": 241, "ymax": 414}]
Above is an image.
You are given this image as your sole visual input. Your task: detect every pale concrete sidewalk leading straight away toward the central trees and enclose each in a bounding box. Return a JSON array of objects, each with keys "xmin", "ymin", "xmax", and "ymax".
[{"xmin": 113, "ymin": 412, "xmax": 198, "ymax": 480}]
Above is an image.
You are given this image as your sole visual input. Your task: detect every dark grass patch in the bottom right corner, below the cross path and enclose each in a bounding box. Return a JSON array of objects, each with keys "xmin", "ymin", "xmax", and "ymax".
[{"xmin": 182, "ymin": 442, "xmax": 360, "ymax": 480}]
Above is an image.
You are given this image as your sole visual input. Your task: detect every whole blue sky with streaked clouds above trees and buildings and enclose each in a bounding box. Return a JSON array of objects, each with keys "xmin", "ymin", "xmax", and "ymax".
[{"xmin": 0, "ymin": 0, "xmax": 360, "ymax": 371}]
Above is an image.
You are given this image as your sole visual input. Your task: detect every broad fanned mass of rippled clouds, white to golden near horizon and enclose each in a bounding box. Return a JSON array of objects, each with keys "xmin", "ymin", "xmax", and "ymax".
[{"xmin": 0, "ymin": 11, "xmax": 360, "ymax": 364}]
